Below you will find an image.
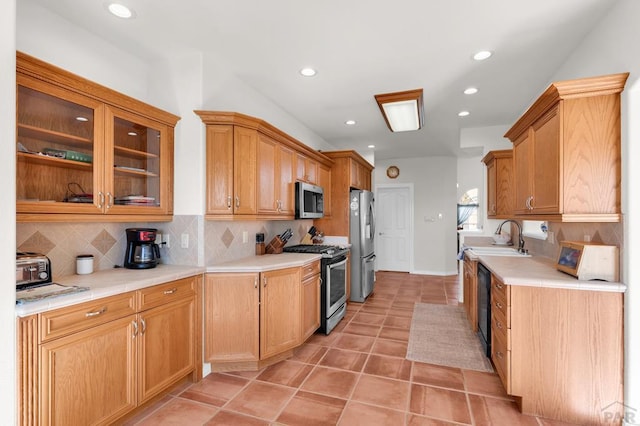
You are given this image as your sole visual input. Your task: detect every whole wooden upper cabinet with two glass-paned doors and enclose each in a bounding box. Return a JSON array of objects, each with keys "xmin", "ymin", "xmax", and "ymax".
[{"xmin": 16, "ymin": 52, "xmax": 179, "ymax": 222}]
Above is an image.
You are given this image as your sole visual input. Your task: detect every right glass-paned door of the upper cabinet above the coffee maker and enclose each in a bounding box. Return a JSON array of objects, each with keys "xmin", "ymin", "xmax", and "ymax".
[{"xmin": 103, "ymin": 107, "xmax": 173, "ymax": 214}]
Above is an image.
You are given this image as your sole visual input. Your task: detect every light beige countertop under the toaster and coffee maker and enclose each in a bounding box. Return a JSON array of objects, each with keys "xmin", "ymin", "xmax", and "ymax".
[{"xmin": 16, "ymin": 264, "xmax": 205, "ymax": 317}]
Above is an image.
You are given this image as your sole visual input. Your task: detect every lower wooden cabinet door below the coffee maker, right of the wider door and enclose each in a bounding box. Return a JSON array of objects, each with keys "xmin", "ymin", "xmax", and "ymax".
[{"xmin": 138, "ymin": 297, "xmax": 195, "ymax": 404}]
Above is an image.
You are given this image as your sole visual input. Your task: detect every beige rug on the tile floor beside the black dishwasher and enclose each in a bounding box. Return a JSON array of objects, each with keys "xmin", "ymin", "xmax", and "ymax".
[{"xmin": 406, "ymin": 303, "xmax": 493, "ymax": 372}]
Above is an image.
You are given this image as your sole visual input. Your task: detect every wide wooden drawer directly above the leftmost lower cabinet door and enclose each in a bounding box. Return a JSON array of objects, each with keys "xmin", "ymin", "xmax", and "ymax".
[{"xmin": 39, "ymin": 292, "xmax": 136, "ymax": 342}]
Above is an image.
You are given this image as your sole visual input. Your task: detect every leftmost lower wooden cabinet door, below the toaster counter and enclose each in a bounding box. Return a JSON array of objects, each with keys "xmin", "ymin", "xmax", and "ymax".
[{"xmin": 39, "ymin": 315, "xmax": 137, "ymax": 425}]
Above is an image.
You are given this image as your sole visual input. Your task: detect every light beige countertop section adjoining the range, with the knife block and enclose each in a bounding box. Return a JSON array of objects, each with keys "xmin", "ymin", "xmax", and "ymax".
[{"xmin": 207, "ymin": 253, "xmax": 322, "ymax": 272}]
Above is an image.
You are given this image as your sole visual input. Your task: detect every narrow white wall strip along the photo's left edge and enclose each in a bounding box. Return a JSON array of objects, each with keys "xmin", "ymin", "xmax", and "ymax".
[{"xmin": 0, "ymin": 0, "xmax": 17, "ymax": 425}]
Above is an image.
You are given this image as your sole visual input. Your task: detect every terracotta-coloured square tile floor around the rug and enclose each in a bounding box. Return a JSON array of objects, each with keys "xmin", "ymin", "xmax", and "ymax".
[{"xmin": 126, "ymin": 272, "xmax": 572, "ymax": 426}]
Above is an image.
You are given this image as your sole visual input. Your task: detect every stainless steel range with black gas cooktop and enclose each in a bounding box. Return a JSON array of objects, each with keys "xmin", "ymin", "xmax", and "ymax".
[{"xmin": 284, "ymin": 244, "xmax": 349, "ymax": 334}]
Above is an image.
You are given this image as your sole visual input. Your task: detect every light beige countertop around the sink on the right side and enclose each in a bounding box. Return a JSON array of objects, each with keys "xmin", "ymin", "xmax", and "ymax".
[{"xmin": 471, "ymin": 256, "xmax": 627, "ymax": 293}]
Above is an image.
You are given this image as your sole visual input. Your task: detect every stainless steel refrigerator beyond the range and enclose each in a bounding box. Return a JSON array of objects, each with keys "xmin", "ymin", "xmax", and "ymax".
[{"xmin": 349, "ymin": 189, "xmax": 376, "ymax": 302}]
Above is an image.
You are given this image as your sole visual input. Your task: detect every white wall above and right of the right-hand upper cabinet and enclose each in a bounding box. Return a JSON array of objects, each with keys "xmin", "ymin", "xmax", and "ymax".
[{"xmin": 540, "ymin": 0, "xmax": 640, "ymax": 424}]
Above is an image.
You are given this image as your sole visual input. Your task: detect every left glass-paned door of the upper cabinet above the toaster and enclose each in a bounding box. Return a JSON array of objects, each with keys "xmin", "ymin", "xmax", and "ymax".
[{"xmin": 16, "ymin": 75, "xmax": 104, "ymax": 214}]
